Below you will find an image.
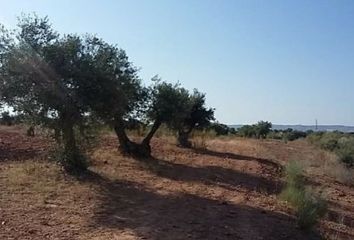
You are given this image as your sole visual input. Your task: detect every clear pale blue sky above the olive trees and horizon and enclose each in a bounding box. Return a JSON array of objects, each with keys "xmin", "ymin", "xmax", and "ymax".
[{"xmin": 0, "ymin": 0, "xmax": 354, "ymax": 125}]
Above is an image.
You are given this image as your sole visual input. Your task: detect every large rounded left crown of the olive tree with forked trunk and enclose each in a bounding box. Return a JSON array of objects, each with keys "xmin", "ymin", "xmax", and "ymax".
[{"xmin": 75, "ymin": 36, "xmax": 147, "ymax": 125}]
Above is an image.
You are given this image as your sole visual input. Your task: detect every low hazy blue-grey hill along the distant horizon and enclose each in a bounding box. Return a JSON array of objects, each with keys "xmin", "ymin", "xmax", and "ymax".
[{"xmin": 229, "ymin": 124, "xmax": 354, "ymax": 132}]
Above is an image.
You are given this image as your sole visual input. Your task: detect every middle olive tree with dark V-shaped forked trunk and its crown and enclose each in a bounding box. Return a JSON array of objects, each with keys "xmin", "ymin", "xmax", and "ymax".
[{"xmin": 79, "ymin": 63, "xmax": 194, "ymax": 157}]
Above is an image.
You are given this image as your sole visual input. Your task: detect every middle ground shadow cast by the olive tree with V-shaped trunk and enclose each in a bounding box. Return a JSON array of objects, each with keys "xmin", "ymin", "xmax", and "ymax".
[{"xmin": 144, "ymin": 158, "xmax": 282, "ymax": 194}]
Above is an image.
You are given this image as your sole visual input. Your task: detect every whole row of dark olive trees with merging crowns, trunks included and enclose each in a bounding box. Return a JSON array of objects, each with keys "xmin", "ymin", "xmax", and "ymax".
[{"xmin": 0, "ymin": 15, "xmax": 216, "ymax": 172}]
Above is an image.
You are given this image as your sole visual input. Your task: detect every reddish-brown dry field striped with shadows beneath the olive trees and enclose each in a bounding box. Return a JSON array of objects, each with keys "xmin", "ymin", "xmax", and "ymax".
[{"xmin": 0, "ymin": 126, "xmax": 354, "ymax": 240}]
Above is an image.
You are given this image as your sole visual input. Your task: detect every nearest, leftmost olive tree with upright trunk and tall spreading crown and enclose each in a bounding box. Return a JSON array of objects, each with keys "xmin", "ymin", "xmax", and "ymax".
[{"xmin": 0, "ymin": 15, "xmax": 88, "ymax": 171}]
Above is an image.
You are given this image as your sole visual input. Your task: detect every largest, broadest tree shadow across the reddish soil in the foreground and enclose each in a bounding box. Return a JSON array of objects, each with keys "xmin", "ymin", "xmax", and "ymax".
[{"xmin": 82, "ymin": 173, "xmax": 320, "ymax": 240}]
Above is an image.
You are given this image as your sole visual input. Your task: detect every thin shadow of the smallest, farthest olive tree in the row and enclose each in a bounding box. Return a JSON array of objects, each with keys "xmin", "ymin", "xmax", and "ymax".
[{"xmin": 193, "ymin": 148, "xmax": 282, "ymax": 172}]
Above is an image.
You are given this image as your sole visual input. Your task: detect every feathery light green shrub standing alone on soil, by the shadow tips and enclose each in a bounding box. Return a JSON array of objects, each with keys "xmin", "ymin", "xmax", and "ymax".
[{"xmin": 281, "ymin": 162, "xmax": 327, "ymax": 230}]
